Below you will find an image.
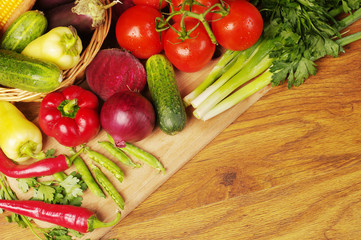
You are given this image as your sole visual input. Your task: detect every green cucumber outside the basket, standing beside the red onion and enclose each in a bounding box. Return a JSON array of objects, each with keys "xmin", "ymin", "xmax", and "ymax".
[{"xmin": 146, "ymin": 54, "xmax": 187, "ymax": 135}]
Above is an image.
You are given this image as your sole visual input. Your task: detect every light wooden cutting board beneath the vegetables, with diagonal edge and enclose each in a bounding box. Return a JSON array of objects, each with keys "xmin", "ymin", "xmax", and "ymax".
[{"xmin": 9, "ymin": 55, "xmax": 269, "ymax": 239}]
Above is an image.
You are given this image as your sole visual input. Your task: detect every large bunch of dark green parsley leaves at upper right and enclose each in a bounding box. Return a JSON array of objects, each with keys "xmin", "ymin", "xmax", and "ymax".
[{"xmin": 261, "ymin": 0, "xmax": 360, "ymax": 88}]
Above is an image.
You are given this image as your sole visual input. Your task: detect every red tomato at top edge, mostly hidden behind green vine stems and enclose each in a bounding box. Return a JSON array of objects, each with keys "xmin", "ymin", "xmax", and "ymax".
[{"xmin": 172, "ymin": 0, "xmax": 219, "ymax": 22}]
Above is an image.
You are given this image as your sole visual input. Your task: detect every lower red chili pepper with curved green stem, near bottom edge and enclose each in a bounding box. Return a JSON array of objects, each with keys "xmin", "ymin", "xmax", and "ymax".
[{"xmin": 0, "ymin": 200, "xmax": 120, "ymax": 233}]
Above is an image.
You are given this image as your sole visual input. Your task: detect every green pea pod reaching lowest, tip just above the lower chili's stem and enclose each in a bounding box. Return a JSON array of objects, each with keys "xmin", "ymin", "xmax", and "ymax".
[{"xmin": 90, "ymin": 164, "xmax": 124, "ymax": 210}]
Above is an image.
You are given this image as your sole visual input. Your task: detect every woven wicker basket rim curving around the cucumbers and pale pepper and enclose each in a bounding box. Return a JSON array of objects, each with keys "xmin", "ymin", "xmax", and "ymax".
[{"xmin": 0, "ymin": 0, "xmax": 111, "ymax": 102}]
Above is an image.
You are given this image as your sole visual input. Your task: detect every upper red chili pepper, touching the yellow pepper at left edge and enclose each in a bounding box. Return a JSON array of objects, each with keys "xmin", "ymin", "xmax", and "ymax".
[{"xmin": 0, "ymin": 149, "xmax": 71, "ymax": 178}]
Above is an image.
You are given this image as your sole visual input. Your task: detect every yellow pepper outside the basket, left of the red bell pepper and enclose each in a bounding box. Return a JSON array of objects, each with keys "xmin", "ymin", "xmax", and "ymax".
[{"xmin": 0, "ymin": 100, "xmax": 45, "ymax": 162}]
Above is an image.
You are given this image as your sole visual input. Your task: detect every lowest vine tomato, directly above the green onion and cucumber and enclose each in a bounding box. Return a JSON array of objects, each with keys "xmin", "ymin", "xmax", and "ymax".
[{"xmin": 164, "ymin": 21, "xmax": 216, "ymax": 72}]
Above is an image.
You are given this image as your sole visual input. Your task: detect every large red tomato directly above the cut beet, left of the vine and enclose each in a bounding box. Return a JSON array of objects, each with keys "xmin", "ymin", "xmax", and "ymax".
[{"xmin": 115, "ymin": 5, "xmax": 165, "ymax": 59}]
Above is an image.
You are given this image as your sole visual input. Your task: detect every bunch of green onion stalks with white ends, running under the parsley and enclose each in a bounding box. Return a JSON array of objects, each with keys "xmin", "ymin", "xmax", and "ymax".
[{"xmin": 187, "ymin": 5, "xmax": 361, "ymax": 121}]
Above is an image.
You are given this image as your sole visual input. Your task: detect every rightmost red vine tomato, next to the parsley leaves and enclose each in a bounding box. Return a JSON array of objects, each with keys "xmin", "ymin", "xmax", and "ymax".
[{"xmin": 212, "ymin": 0, "xmax": 263, "ymax": 51}]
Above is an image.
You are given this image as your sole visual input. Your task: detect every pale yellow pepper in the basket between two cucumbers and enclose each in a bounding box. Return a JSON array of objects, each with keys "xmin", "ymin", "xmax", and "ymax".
[{"xmin": 21, "ymin": 26, "xmax": 83, "ymax": 70}]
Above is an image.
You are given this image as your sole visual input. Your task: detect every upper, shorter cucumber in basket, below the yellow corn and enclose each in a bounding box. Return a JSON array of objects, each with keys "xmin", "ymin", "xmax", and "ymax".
[{"xmin": 0, "ymin": 10, "xmax": 48, "ymax": 53}]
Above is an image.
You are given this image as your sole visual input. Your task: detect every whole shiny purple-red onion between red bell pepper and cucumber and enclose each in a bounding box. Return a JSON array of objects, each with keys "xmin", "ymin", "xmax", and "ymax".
[{"xmin": 100, "ymin": 91, "xmax": 155, "ymax": 147}]
